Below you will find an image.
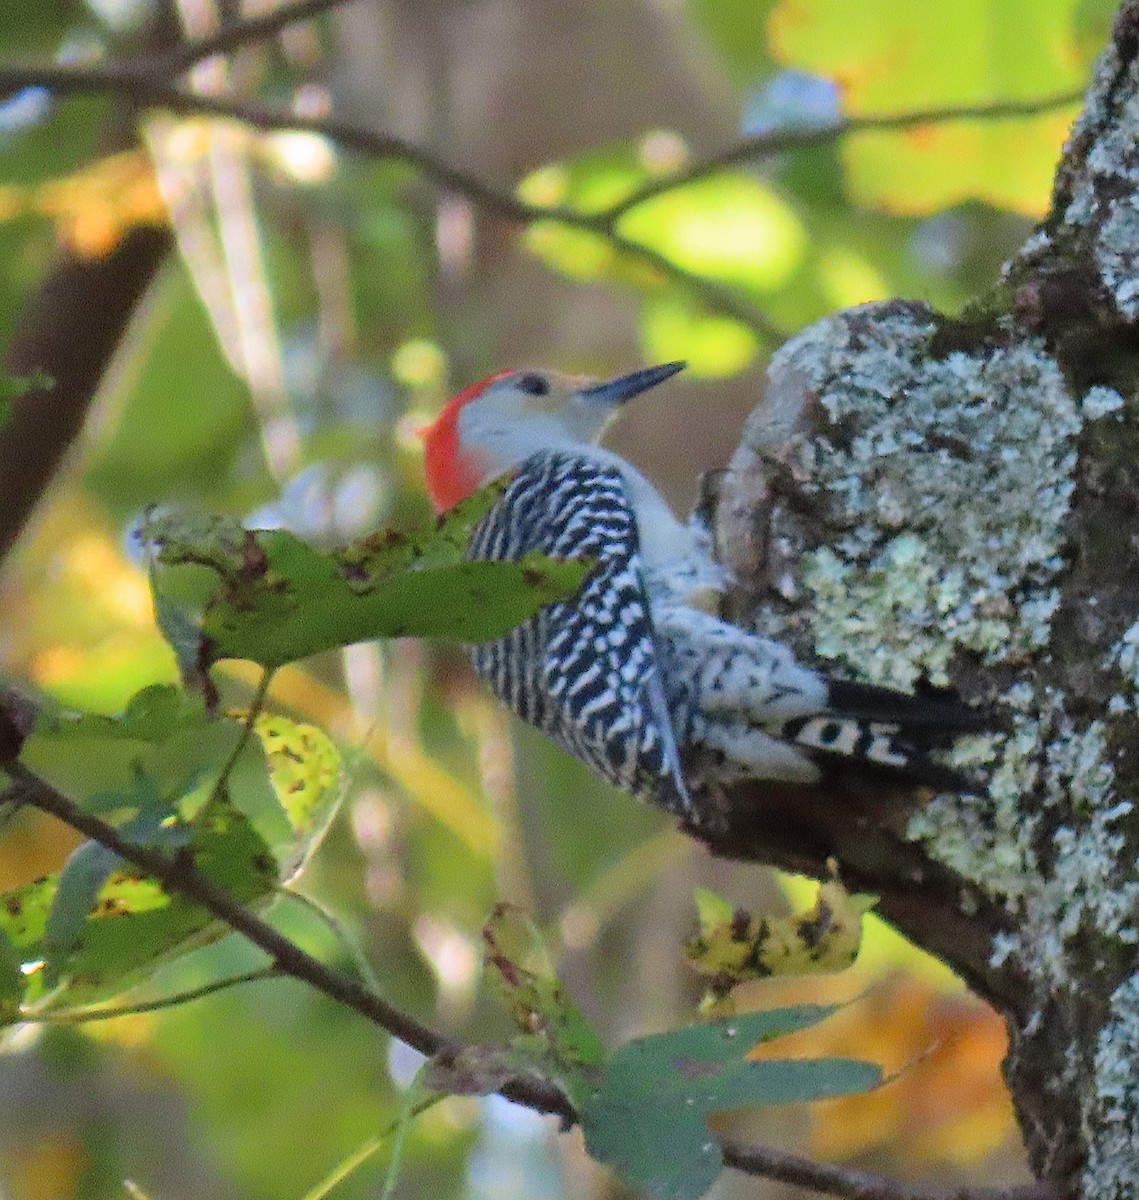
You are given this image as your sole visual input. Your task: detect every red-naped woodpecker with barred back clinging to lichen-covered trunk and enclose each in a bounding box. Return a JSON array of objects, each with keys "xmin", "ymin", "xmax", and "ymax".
[{"xmin": 424, "ymin": 362, "xmax": 978, "ymax": 817}]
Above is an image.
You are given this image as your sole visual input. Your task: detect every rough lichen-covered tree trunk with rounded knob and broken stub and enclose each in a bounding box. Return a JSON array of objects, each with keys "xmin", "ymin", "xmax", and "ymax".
[{"xmin": 696, "ymin": 0, "xmax": 1139, "ymax": 1200}]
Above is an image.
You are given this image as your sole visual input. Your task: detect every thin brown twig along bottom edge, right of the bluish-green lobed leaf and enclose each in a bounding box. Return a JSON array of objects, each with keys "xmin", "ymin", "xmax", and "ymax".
[{"xmin": 720, "ymin": 1138, "xmax": 1066, "ymax": 1200}]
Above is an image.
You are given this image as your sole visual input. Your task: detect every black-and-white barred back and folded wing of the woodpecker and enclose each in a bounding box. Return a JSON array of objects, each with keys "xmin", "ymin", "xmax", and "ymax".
[{"xmin": 467, "ymin": 451, "xmax": 690, "ymax": 812}]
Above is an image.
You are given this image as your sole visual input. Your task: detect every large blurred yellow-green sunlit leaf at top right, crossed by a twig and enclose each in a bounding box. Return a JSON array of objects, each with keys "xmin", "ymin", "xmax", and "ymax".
[{"xmin": 769, "ymin": 0, "xmax": 1087, "ymax": 215}]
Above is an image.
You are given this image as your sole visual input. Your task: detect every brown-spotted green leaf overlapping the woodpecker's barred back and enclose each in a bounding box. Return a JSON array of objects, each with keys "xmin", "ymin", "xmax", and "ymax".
[{"xmin": 143, "ymin": 485, "xmax": 589, "ymax": 667}]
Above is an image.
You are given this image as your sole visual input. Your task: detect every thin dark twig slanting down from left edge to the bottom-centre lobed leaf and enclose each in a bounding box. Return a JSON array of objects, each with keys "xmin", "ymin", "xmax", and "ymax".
[{"xmin": 4, "ymin": 762, "xmax": 576, "ymax": 1122}]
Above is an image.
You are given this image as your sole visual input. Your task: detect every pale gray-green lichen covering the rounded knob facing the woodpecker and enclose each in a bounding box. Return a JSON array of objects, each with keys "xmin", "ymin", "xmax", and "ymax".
[{"xmin": 761, "ymin": 305, "xmax": 1080, "ymax": 688}]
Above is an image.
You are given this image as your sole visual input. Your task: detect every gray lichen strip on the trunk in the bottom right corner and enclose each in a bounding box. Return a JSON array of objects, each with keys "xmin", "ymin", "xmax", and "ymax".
[{"xmin": 1080, "ymin": 976, "xmax": 1139, "ymax": 1200}]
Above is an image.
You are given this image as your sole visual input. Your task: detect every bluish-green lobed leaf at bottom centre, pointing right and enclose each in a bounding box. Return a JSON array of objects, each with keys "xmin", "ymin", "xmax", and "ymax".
[{"xmin": 582, "ymin": 1006, "xmax": 882, "ymax": 1200}]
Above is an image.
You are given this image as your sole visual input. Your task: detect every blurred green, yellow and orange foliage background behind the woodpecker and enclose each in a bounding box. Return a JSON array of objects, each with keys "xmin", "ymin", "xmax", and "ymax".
[{"xmin": 0, "ymin": 0, "xmax": 1113, "ymax": 1200}]
